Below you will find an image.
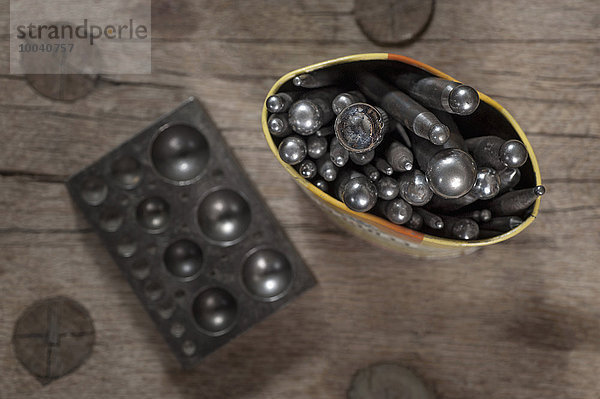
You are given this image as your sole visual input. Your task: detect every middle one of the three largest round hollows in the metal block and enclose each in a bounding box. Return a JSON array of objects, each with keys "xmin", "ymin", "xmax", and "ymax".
[{"xmin": 197, "ymin": 189, "xmax": 252, "ymax": 243}]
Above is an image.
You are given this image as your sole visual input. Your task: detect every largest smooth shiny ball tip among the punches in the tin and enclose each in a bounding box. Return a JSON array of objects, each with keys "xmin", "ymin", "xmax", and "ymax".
[{"xmin": 425, "ymin": 148, "xmax": 477, "ymax": 198}]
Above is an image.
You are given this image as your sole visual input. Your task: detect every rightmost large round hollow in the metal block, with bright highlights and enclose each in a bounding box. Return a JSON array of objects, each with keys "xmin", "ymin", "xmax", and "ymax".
[{"xmin": 242, "ymin": 249, "xmax": 293, "ymax": 300}]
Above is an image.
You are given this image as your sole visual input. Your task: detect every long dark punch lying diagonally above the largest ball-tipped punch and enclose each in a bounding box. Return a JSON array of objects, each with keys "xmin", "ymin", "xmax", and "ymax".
[{"xmin": 356, "ymin": 72, "xmax": 450, "ymax": 145}]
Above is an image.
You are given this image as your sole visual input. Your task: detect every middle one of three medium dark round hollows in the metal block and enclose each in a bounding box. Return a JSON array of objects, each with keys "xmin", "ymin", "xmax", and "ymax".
[{"xmin": 163, "ymin": 240, "xmax": 203, "ymax": 278}]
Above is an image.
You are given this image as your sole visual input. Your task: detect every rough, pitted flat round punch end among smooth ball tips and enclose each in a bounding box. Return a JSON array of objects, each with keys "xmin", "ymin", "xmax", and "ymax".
[{"xmin": 333, "ymin": 103, "xmax": 389, "ymax": 153}]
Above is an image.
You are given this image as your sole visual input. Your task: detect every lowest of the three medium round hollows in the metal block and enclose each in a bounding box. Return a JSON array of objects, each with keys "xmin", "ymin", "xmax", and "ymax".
[{"xmin": 192, "ymin": 287, "xmax": 238, "ymax": 335}]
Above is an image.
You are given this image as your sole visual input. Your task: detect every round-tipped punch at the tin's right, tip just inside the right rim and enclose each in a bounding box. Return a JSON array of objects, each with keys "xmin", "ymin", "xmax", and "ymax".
[{"xmin": 465, "ymin": 136, "xmax": 528, "ymax": 170}]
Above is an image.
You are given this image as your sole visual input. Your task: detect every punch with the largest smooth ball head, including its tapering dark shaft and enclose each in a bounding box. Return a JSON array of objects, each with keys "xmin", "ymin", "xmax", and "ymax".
[{"xmin": 411, "ymin": 135, "xmax": 477, "ymax": 198}]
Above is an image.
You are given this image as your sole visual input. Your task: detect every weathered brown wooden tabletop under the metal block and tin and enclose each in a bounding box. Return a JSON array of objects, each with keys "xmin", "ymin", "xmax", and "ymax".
[{"xmin": 0, "ymin": 0, "xmax": 600, "ymax": 399}]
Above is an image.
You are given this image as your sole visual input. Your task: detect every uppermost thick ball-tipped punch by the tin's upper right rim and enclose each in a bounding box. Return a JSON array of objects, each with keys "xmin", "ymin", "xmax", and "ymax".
[{"xmin": 394, "ymin": 73, "xmax": 479, "ymax": 115}]
